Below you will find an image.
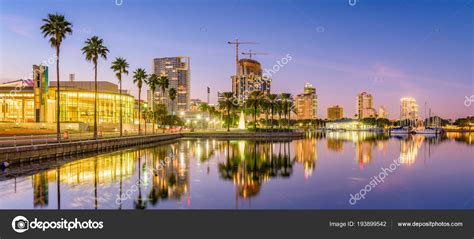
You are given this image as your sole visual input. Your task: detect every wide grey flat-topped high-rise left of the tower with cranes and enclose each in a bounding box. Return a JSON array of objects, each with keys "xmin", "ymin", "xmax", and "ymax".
[{"xmin": 152, "ymin": 56, "xmax": 191, "ymax": 114}]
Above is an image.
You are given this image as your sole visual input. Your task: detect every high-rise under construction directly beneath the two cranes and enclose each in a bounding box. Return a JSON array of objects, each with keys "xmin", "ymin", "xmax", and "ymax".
[{"xmin": 231, "ymin": 59, "xmax": 272, "ymax": 101}]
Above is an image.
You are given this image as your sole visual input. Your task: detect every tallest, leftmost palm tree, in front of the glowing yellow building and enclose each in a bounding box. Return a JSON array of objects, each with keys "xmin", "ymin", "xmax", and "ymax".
[{"xmin": 40, "ymin": 13, "xmax": 72, "ymax": 141}]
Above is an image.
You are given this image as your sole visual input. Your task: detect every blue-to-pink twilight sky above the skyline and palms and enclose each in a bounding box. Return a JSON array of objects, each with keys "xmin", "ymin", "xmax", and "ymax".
[{"xmin": 0, "ymin": 0, "xmax": 474, "ymax": 118}]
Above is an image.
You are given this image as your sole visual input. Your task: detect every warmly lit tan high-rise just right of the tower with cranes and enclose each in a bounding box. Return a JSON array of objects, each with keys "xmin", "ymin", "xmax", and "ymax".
[{"xmin": 295, "ymin": 83, "xmax": 318, "ymax": 120}]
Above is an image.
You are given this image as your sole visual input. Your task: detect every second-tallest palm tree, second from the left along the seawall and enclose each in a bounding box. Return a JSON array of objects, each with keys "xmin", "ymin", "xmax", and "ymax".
[{"xmin": 82, "ymin": 36, "xmax": 109, "ymax": 139}]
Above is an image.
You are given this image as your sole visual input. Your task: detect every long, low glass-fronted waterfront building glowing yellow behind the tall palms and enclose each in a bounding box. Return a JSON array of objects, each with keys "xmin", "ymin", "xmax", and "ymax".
[{"xmin": 0, "ymin": 66, "xmax": 135, "ymax": 131}]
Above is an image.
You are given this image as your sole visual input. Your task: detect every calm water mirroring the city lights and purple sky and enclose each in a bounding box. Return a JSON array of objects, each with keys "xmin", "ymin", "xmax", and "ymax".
[{"xmin": 0, "ymin": 132, "xmax": 474, "ymax": 209}]
